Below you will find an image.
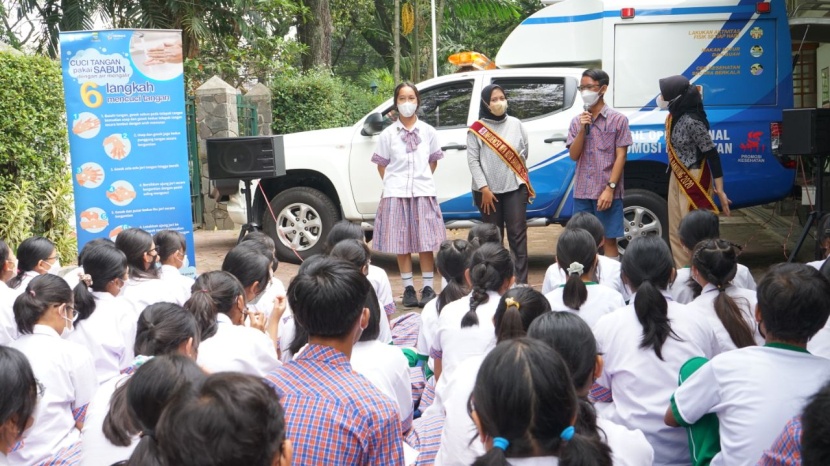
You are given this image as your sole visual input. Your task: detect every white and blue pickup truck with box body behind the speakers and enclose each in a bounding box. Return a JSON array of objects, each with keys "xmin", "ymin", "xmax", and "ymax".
[{"xmin": 228, "ymin": 0, "xmax": 794, "ymax": 260}]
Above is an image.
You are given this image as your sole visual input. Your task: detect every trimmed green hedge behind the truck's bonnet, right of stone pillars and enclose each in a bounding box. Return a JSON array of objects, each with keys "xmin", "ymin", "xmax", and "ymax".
[{"xmin": 271, "ymin": 70, "xmax": 391, "ymax": 134}]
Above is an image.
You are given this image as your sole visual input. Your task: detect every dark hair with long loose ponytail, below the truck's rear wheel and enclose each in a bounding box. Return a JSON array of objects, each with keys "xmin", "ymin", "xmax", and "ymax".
[{"xmin": 622, "ymin": 236, "xmax": 680, "ymax": 360}]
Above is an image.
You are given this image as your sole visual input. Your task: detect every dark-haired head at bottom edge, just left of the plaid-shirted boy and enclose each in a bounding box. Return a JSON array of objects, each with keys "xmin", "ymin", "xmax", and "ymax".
[{"xmin": 156, "ymin": 373, "xmax": 294, "ymax": 466}]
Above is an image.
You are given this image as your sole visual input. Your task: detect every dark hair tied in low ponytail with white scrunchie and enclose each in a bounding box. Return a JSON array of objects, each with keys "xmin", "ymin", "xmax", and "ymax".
[{"xmin": 556, "ymin": 228, "xmax": 597, "ymax": 311}]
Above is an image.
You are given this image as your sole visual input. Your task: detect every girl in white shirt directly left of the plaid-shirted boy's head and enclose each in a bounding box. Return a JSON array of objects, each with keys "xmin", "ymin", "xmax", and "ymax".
[{"xmin": 189, "ymin": 272, "xmax": 281, "ymax": 377}]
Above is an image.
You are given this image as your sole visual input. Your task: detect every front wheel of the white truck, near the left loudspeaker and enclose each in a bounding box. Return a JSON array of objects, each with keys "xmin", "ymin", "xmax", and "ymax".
[{"xmin": 262, "ymin": 187, "xmax": 340, "ymax": 264}]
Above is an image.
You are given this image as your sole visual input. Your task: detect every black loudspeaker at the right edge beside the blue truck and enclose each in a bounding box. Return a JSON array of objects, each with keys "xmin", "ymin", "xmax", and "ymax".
[{"xmin": 780, "ymin": 108, "xmax": 830, "ymax": 155}]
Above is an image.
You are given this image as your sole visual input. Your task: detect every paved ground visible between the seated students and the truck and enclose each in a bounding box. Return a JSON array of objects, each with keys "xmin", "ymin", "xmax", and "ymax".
[{"xmin": 196, "ymin": 205, "xmax": 824, "ymax": 314}]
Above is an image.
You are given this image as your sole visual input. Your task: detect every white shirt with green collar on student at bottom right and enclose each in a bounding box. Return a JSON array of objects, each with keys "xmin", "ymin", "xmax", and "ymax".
[{"xmin": 674, "ymin": 345, "xmax": 830, "ymax": 466}]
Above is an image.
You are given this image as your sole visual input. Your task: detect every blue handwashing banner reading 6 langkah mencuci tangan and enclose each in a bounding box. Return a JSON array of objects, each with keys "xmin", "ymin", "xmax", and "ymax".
[{"xmin": 60, "ymin": 29, "xmax": 196, "ymax": 276}]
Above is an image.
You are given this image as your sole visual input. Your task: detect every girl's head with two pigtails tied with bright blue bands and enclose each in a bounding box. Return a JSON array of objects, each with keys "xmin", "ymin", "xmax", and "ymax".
[{"xmin": 469, "ymin": 338, "xmax": 612, "ymax": 466}]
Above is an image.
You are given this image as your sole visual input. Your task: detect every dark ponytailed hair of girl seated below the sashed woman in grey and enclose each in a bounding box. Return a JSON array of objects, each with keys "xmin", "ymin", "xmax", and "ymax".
[{"xmin": 461, "ymin": 243, "xmax": 513, "ymax": 328}]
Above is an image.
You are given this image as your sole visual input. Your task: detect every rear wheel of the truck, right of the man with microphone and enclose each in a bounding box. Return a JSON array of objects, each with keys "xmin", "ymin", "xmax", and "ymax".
[{"xmin": 617, "ymin": 189, "xmax": 669, "ymax": 254}]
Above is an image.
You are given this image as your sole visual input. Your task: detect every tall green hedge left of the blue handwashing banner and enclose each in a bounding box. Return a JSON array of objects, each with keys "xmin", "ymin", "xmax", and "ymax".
[{"xmin": 0, "ymin": 53, "xmax": 77, "ymax": 263}]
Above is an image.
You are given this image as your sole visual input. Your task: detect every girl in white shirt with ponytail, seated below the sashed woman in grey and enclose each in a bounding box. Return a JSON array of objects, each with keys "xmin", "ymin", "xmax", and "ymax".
[{"xmin": 430, "ymin": 243, "xmax": 513, "ymax": 384}]
